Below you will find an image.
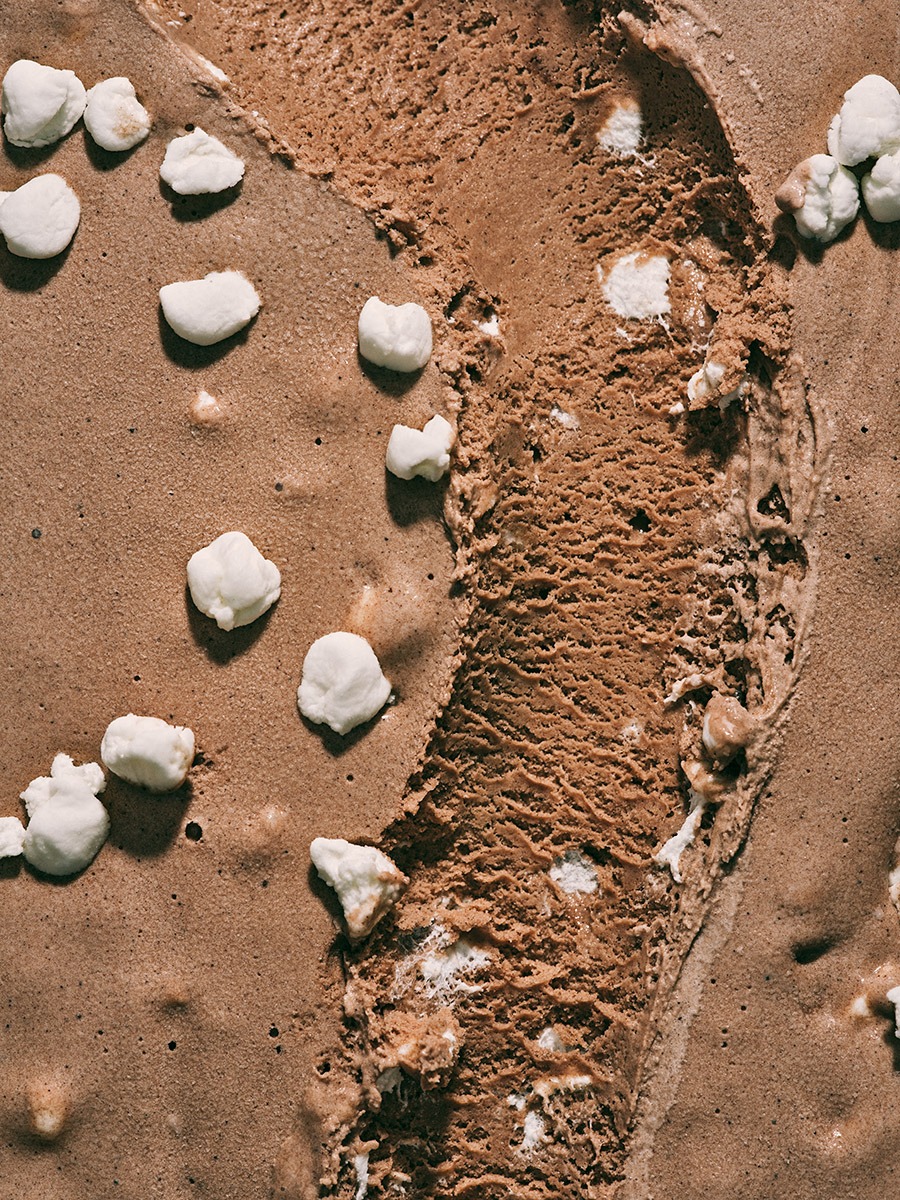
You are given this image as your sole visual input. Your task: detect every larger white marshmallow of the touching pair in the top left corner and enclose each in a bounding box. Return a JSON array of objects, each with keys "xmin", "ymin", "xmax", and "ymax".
[{"xmin": 0, "ymin": 59, "xmax": 86, "ymax": 146}]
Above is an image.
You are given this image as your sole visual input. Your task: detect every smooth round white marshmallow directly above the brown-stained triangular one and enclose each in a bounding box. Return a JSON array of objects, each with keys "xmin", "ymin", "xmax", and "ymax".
[{"xmin": 296, "ymin": 632, "xmax": 391, "ymax": 733}]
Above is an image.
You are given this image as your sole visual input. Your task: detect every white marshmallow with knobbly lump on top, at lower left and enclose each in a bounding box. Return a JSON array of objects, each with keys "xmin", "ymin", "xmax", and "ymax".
[{"xmin": 22, "ymin": 754, "xmax": 109, "ymax": 875}]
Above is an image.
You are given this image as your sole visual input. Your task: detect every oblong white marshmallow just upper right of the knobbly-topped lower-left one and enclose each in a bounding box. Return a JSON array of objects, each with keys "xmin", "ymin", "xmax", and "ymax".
[{"xmin": 100, "ymin": 713, "xmax": 194, "ymax": 792}]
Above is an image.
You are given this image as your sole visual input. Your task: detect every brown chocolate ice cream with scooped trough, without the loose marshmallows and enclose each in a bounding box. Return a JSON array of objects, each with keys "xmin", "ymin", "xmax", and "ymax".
[{"xmin": 0, "ymin": 0, "xmax": 900, "ymax": 1200}]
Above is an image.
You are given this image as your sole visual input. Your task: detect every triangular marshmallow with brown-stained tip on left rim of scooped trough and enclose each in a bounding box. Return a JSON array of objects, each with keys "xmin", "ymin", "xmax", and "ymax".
[{"xmin": 310, "ymin": 838, "xmax": 408, "ymax": 940}]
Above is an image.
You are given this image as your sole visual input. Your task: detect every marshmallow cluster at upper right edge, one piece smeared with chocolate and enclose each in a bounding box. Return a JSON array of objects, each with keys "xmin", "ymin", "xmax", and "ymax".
[{"xmin": 775, "ymin": 74, "xmax": 900, "ymax": 242}]
